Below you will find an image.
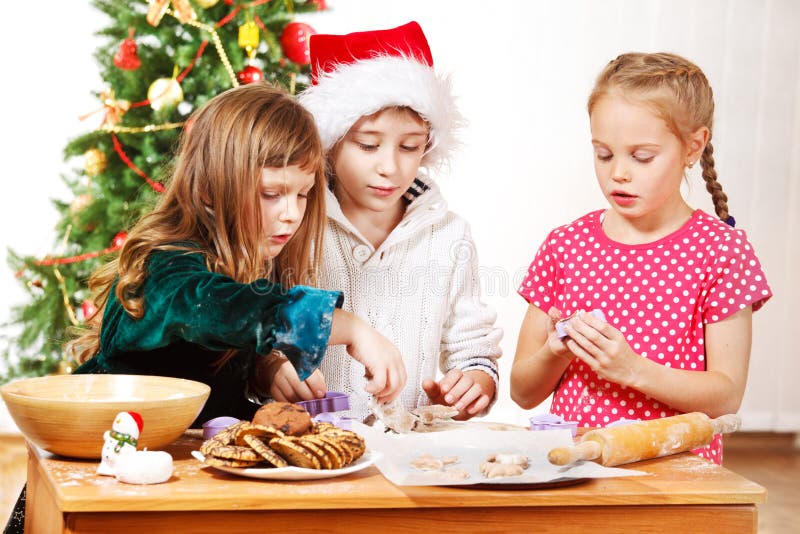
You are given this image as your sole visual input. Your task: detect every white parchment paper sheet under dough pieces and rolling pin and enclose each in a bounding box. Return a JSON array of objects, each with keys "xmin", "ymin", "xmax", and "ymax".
[{"xmin": 353, "ymin": 423, "xmax": 647, "ymax": 486}]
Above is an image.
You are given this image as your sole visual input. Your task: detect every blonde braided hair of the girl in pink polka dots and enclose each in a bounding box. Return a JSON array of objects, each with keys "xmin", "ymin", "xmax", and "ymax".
[{"xmin": 587, "ymin": 52, "xmax": 732, "ymax": 224}]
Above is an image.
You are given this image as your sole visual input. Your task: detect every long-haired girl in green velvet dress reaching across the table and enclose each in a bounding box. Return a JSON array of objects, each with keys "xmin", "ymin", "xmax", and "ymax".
[{"xmin": 71, "ymin": 82, "xmax": 406, "ymax": 424}]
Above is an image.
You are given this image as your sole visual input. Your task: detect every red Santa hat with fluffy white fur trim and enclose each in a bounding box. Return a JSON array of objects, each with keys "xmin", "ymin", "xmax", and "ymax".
[{"xmin": 299, "ymin": 22, "xmax": 463, "ymax": 168}]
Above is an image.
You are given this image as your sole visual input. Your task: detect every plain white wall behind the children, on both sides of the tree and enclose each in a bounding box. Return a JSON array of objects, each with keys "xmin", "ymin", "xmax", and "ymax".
[{"xmin": 0, "ymin": 0, "xmax": 800, "ymax": 430}]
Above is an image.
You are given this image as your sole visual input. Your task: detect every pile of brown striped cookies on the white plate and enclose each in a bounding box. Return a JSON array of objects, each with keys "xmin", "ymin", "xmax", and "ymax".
[{"xmin": 200, "ymin": 403, "xmax": 366, "ymax": 469}]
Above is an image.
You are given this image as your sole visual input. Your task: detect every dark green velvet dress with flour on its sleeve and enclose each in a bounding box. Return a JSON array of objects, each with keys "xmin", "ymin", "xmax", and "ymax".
[{"xmin": 75, "ymin": 251, "xmax": 342, "ymax": 426}]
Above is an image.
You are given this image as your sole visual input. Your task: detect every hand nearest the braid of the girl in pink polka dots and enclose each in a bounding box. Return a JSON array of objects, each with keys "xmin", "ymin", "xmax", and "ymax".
[{"xmin": 564, "ymin": 312, "xmax": 642, "ymax": 387}]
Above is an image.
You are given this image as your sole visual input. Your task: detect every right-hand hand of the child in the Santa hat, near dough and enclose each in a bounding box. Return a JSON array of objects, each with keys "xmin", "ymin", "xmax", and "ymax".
[{"xmin": 422, "ymin": 369, "xmax": 495, "ymax": 420}]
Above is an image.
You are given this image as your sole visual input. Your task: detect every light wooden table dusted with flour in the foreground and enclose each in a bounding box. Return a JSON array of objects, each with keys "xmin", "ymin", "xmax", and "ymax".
[{"xmin": 26, "ymin": 436, "xmax": 766, "ymax": 534}]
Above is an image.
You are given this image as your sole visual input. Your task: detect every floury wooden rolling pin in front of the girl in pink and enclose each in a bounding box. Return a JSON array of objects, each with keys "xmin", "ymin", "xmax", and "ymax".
[{"xmin": 547, "ymin": 412, "xmax": 741, "ymax": 466}]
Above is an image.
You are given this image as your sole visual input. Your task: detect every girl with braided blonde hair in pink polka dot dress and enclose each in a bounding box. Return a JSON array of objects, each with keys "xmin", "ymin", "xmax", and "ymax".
[{"xmin": 511, "ymin": 53, "xmax": 772, "ymax": 463}]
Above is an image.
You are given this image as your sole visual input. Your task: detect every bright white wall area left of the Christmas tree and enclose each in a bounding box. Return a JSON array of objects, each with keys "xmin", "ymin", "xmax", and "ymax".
[{"xmin": 0, "ymin": 2, "xmax": 105, "ymax": 433}]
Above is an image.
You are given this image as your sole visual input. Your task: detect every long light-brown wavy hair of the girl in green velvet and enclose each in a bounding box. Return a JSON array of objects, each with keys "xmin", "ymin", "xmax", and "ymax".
[{"xmin": 68, "ymin": 82, "xmax": 325, "ymax": 366}]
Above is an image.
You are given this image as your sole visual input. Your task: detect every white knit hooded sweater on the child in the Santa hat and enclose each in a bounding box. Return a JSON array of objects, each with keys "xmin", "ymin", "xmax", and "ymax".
[{"xmin": 319, "ymin": 178, "xmax": 502, "ymax": 420}]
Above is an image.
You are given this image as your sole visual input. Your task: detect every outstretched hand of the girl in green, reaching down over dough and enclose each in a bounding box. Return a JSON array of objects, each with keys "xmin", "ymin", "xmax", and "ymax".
[{"xmin": 347, "ymin": 323, "xmax": 406, "ymax": 403}]
